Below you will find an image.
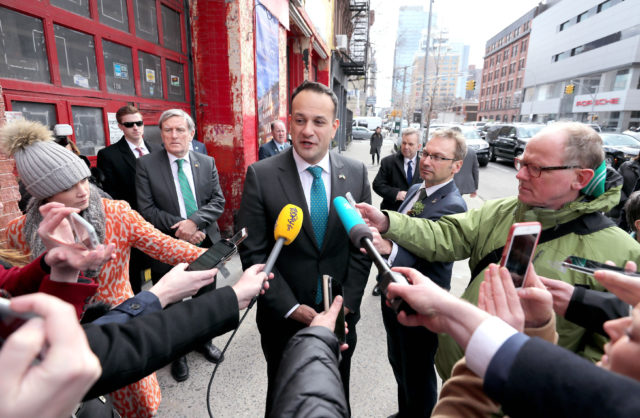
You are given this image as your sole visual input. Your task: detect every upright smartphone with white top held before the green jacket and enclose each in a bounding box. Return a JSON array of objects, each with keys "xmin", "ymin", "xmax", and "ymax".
[{"xmin": 500, "ymin": 222, "xmax": 542, "ymax": 289}]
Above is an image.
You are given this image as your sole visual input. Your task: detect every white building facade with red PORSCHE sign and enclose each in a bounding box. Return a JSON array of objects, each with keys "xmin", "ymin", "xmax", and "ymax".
[{"xmin": 520, "ymin": 0, "xmax": 640, "ymax": 131}]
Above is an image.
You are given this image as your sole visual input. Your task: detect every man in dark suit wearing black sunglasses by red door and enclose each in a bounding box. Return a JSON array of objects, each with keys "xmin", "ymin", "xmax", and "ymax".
[{"xmin": 98, "ymin": 105, "xmax": 161, "ymax": 293}]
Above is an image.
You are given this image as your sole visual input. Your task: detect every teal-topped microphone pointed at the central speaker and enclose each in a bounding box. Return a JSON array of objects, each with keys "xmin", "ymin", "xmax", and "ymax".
[{"xmin": 333, "ymin": 196, "xmax": 415, "ymax": 315}]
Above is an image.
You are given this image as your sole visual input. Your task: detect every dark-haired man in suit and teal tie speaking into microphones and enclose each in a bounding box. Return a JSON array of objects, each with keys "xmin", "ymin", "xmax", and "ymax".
[{"xmin": 238, "ymin": 81, "xmax": 371, "ymax": 415}]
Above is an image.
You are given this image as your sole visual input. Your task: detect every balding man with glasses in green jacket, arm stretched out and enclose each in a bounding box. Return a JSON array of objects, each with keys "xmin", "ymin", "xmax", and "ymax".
[{"xmin": 358, "ymin": 122, "xmax": 640, "ymax": 379}]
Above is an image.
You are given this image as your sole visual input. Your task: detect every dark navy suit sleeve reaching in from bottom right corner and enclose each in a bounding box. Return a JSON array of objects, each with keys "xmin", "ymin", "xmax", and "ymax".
[{"xmin": 483, "ymin": 337, "xmax": 640, "ymax": 417}]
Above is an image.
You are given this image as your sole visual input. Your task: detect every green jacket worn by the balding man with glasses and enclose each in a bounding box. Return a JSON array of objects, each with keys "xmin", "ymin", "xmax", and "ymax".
[{"xmin": 384, "ymin": 186, "xmax": 640, "ymax": 379}]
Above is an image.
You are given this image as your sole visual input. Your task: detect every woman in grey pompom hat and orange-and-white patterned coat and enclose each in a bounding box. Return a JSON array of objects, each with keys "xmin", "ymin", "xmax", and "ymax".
[{"xmin": 0, "ymin": 120, "xmax": 205, "ymax": 417}]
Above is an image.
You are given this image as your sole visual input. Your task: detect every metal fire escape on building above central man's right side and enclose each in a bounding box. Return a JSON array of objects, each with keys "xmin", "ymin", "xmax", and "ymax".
[{"xmin": 341, "ymin": 0, "xmax": 369, "ymax": 77}]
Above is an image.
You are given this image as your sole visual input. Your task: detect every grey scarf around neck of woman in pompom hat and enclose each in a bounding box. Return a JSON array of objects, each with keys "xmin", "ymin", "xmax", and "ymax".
[{"xmin": 24, "ymin": 184, "xmax": 106, "ymax": 277}]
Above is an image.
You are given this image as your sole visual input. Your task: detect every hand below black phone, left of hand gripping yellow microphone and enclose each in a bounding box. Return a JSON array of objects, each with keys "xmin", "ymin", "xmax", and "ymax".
[{"xmin": 149, "ymin": 263, "xmax": 218, "ymax": 308}]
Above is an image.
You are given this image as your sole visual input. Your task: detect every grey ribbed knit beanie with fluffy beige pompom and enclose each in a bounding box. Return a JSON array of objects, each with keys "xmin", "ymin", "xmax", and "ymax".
[{"xmin": 0, "ymin": 120, "xmax": 91, "ymax": 200}]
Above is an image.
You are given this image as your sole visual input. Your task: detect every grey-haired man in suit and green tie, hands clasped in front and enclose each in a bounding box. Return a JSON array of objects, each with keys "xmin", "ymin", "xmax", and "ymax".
[{"xmin": 136, "ymin": 109, "xmax": 225, "ymax": 381}]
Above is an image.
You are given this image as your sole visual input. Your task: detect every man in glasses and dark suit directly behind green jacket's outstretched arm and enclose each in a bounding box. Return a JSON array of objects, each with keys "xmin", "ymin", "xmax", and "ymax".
[{"xmin": 381, "ymin": 129, "xmax": 467, "ymax": 417}]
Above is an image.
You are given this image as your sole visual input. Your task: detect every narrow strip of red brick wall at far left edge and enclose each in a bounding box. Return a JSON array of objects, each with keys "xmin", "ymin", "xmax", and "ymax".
[{"xmin": 0, "ymin": 86, "xmax": 21, "ymax": 247}]
